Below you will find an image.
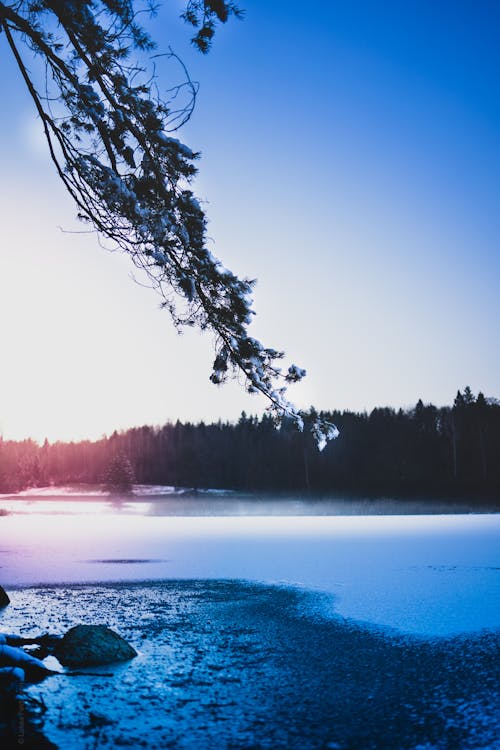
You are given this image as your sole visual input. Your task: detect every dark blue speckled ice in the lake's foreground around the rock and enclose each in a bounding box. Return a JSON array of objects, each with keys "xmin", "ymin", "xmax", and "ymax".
[{"xmin": 0, "ymin": 580, "xmax": 500, "ymax": 750}]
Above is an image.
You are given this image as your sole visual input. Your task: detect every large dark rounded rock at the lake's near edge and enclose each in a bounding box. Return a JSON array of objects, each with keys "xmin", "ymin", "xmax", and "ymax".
[{"xmin": 54, "ymin": 625, "xmax": 137, "ymax": 667}]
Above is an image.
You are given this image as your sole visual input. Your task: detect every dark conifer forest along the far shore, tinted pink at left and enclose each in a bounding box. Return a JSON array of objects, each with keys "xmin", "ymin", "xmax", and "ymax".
[{"xmin": 0, "ymin": 387, "xmax": 500, "ymax": 500}]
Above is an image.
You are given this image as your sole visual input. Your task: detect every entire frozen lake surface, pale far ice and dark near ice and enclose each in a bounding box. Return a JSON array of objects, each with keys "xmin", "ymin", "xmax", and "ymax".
[{"xmin": 0, "ymin": 493, "xmax": 500, "ymax": 750}]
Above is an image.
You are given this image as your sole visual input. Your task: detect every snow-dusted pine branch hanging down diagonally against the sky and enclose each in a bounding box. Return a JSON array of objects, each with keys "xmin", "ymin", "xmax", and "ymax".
[{"xmin": 0, "ymin": 0, "xmax": 334, "ymax": 445}]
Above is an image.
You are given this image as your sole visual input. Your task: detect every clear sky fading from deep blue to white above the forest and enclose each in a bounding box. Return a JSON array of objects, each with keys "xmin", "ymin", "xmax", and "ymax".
[{"xmin": 0, "ymin": 0, "xmax": 500, "ymax": 440}]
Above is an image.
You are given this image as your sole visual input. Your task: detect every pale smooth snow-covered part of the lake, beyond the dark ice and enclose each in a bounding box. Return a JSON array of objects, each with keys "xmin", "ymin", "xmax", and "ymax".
[{"xmin": 0, "ymin": 497, "xmax": 500, "ymax": 636}]
